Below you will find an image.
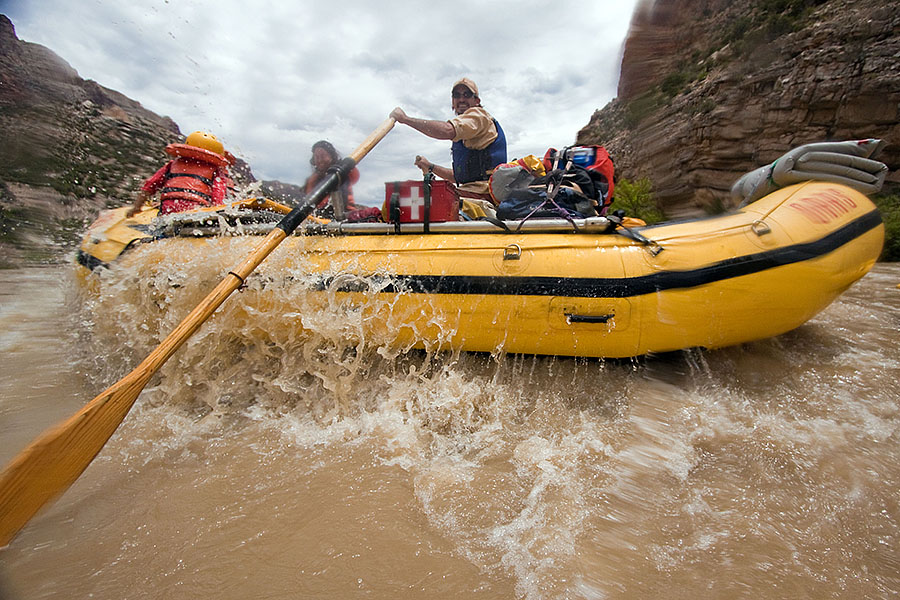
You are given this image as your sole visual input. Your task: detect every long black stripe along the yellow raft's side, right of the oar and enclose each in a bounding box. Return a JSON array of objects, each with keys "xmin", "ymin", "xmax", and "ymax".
[{"xmin": 320, "ymin": 210, "xmax": 881, "ymax": 298}]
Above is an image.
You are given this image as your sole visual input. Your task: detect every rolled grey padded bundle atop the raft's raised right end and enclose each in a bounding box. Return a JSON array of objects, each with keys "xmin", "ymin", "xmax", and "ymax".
[{"xmin": 731, "ymin": 138, "xmax": 888, "ymax": 206}]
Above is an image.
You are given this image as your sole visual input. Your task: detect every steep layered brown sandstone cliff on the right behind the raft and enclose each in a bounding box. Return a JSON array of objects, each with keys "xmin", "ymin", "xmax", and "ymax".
[{"xmin": 578, "ymin": 0, "xmax": 900, "ymax": 216}]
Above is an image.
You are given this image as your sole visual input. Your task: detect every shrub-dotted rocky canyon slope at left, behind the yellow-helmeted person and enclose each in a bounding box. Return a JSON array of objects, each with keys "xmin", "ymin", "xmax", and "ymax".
[{"xmin": 0, "ymin": 15, "xmax": 186, "ymax": 266}]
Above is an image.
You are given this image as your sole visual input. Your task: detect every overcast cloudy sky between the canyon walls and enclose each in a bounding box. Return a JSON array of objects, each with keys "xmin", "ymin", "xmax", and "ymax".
[{"xmin": 0, "ymin": 0, "xmax": 636, "ymax": 205}]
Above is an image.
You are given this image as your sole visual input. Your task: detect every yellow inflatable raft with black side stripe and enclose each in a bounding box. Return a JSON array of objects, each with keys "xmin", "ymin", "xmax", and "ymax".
[{"xmin": 78, "ymin": 182, "xmax": 884, "ymax": 357}]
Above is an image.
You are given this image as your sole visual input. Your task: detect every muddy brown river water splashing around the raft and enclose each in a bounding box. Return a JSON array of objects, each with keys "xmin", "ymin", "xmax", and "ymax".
[{"xmin": 0, "ymin": 264, "xmax": 900, "ymax": 600}]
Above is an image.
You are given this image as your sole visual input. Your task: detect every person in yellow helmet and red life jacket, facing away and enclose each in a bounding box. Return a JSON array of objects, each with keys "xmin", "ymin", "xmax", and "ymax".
[{"xmin": 126, "ymin": 131, "xmax": 234, "ymax": 217}]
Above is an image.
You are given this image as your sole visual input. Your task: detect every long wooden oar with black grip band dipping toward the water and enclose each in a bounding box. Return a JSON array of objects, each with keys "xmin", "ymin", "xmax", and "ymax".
[{"xmin": 0, "ymin": 119, "xmax": 394, "ymax": 548}]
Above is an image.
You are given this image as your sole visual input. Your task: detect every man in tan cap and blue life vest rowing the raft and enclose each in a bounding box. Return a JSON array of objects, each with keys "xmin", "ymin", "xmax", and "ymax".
[{"xmin": 391, "ymin": 77, "xmax": 506, "ymax": 200}]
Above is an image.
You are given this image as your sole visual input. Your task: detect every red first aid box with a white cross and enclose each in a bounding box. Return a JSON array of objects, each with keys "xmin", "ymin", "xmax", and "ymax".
[{"xmin": 382, "ymin": 180, "xmax": 459, "ymax": 223}]
